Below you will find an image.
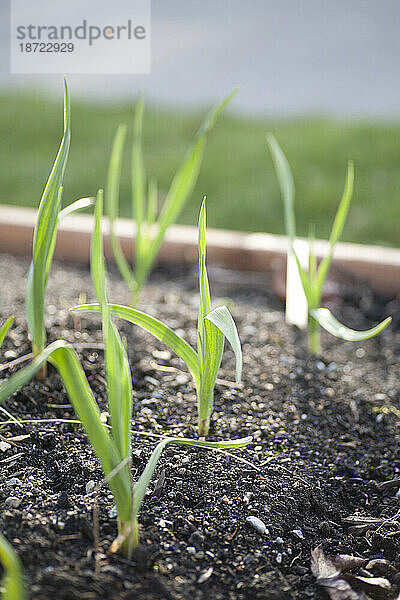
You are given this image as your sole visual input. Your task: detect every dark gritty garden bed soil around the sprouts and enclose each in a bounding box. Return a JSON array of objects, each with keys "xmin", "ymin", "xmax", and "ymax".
[{"xmin": 0, "ymin": 256, "xmax": 400, "ymax": 600}]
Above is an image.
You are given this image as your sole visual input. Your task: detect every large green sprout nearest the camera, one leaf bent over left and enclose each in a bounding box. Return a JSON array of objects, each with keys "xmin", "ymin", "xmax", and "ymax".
[{"xmin": 0, "ymin": 191, "xmax": 252, "ymax": 556}]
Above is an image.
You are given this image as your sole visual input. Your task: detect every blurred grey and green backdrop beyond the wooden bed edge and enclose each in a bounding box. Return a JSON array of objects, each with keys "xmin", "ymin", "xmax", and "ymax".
[{"xmin": 0, "ymin": 0, "xmax": 400, "ymax": 246}]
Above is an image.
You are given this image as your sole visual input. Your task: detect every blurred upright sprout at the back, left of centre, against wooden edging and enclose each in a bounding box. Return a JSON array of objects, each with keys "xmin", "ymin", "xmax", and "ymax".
[{"xmin": 106, "ymin": 90, "xmax": 236, "ymax": 307}]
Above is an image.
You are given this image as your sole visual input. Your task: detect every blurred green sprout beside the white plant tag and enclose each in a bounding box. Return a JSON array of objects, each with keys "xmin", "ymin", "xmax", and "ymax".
[{"xmin": 267, "ymin": 133, "xmax": 392, "ymax": 354}]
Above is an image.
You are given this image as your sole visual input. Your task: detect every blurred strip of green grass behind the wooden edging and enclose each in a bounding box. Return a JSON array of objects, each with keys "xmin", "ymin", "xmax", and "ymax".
[{"xmin": 0, "ymin": 92, "xmax": 400, "ymax": 246}]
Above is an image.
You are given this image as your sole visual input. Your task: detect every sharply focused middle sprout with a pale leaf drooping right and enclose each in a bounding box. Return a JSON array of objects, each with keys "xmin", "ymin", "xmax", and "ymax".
[{"xmin": 71, "ymin": 199, "xmax": 242, "ymax": 437}]
